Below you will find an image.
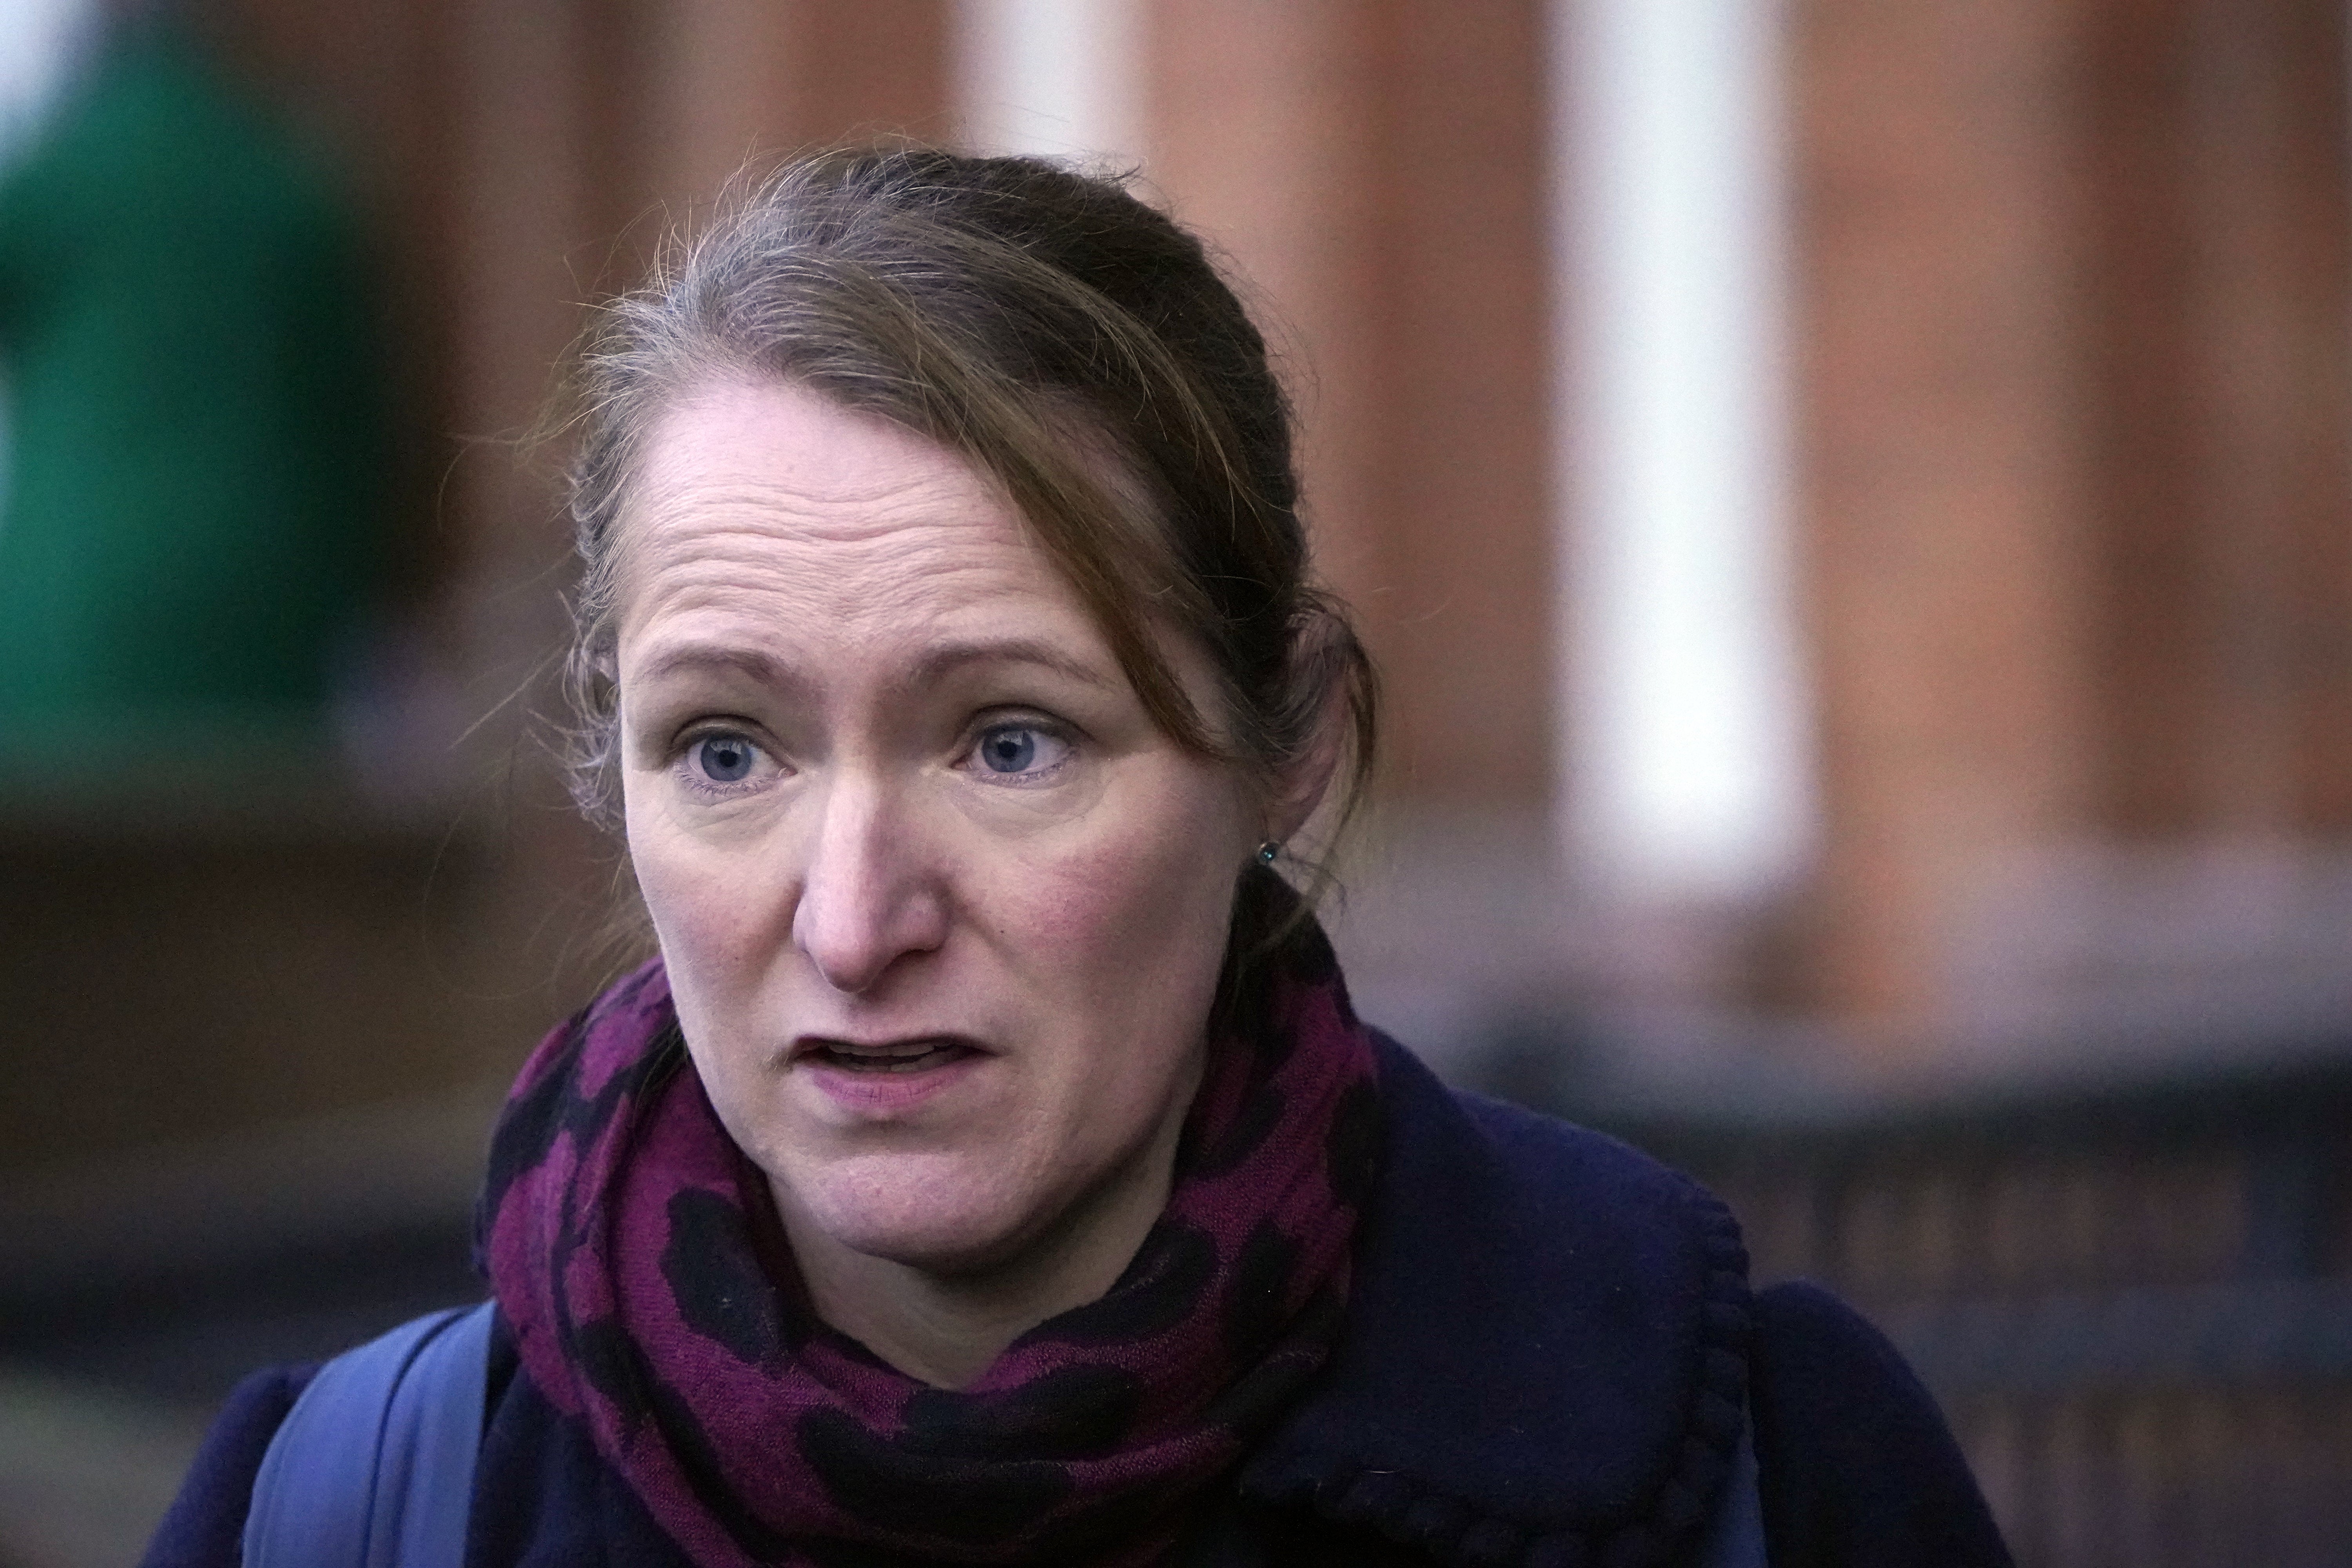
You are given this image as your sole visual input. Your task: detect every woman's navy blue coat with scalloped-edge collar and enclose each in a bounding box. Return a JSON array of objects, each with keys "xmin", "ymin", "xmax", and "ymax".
[{"xmin": 146, "ymin": 1039, "xmax": 2009, "ymax": 1568}]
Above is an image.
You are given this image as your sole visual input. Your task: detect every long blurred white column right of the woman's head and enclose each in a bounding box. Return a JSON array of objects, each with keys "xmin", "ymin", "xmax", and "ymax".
[{"xmin": 1552, "ymin": 0, "xmax": 1813, "ymax": 898}]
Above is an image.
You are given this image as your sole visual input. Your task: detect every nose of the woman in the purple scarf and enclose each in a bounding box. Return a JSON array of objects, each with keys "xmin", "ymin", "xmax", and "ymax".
[{"xmin": 793, "ymin": 780, "xmax": 948, "ymax": 995}]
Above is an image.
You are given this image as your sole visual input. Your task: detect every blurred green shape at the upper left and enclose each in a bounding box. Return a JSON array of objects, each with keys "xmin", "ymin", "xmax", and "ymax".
[{"xmin": 0, "ymin": 28, "xmax": 383, "ymax": 762}]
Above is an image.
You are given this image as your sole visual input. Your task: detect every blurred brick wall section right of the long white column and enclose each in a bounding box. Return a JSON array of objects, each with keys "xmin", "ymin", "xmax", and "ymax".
[{"xmin": 1790, "ymin": 0, "xmax": 2352, "ymax": 1051}]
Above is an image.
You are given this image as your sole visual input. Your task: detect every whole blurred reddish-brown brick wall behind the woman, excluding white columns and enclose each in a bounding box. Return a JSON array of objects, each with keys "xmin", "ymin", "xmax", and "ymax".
[{"xmin": 0, "ymin": 0, "xmax": 2352, "ymax": 1164}]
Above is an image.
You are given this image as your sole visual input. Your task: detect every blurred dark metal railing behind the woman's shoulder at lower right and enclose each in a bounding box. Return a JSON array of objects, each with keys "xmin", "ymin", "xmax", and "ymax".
[{"xmin": 1519, "ymin": 1044, "xmax": 2352, "ymax": 1568}]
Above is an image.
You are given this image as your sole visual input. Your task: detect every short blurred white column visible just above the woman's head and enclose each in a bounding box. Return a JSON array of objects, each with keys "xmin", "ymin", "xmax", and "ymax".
[{"xmin": 950, "ymin": 0, "xmax": 1143, "ymax": 165}]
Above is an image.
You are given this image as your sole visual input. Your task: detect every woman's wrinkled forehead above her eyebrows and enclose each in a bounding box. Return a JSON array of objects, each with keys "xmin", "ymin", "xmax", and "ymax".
[{"xmin": 619, "ymin": 383, "xmax": 1098, "ymax": 646}]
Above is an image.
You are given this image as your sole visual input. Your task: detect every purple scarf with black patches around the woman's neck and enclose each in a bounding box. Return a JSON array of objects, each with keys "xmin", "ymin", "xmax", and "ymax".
[{"xmin": 482, "ymin": 907, "xmax": 1378, "ymax": 1568}]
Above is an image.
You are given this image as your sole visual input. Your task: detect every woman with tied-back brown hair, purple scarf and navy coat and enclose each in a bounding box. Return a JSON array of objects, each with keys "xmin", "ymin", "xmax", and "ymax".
[{"xmin": 148, "ymin": 151, "xmax": 2006, "ymax": 1568}]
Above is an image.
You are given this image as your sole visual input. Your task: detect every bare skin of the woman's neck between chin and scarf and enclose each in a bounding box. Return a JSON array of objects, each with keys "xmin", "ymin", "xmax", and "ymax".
[{"xmin": 769, "ymin": 1074, "xmax": 1197, "ymax": 1389}]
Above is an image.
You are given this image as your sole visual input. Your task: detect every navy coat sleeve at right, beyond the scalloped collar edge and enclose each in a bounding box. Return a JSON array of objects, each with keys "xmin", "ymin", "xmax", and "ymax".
[{"xmin": 1752, "ymin": 1283, "xmax": 2009, "ymax": 1568}]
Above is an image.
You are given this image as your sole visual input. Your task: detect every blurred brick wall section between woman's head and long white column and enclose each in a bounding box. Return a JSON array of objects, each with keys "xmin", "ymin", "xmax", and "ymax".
[{"xmin": 1145, "ymin": 0, "xmax": 1557, "ymax": 808}]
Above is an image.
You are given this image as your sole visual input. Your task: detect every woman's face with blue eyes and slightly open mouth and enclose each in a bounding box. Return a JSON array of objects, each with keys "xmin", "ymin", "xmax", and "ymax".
[{"xmin": 619, "ymin": 386, "xmax": 1261, "ymax": 1272}]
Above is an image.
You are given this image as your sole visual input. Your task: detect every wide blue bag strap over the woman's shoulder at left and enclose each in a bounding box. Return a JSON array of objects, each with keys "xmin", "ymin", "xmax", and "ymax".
[{"xmin": 245, "ymin": 1302, "xmax": 492, "ymax": 1568}]
